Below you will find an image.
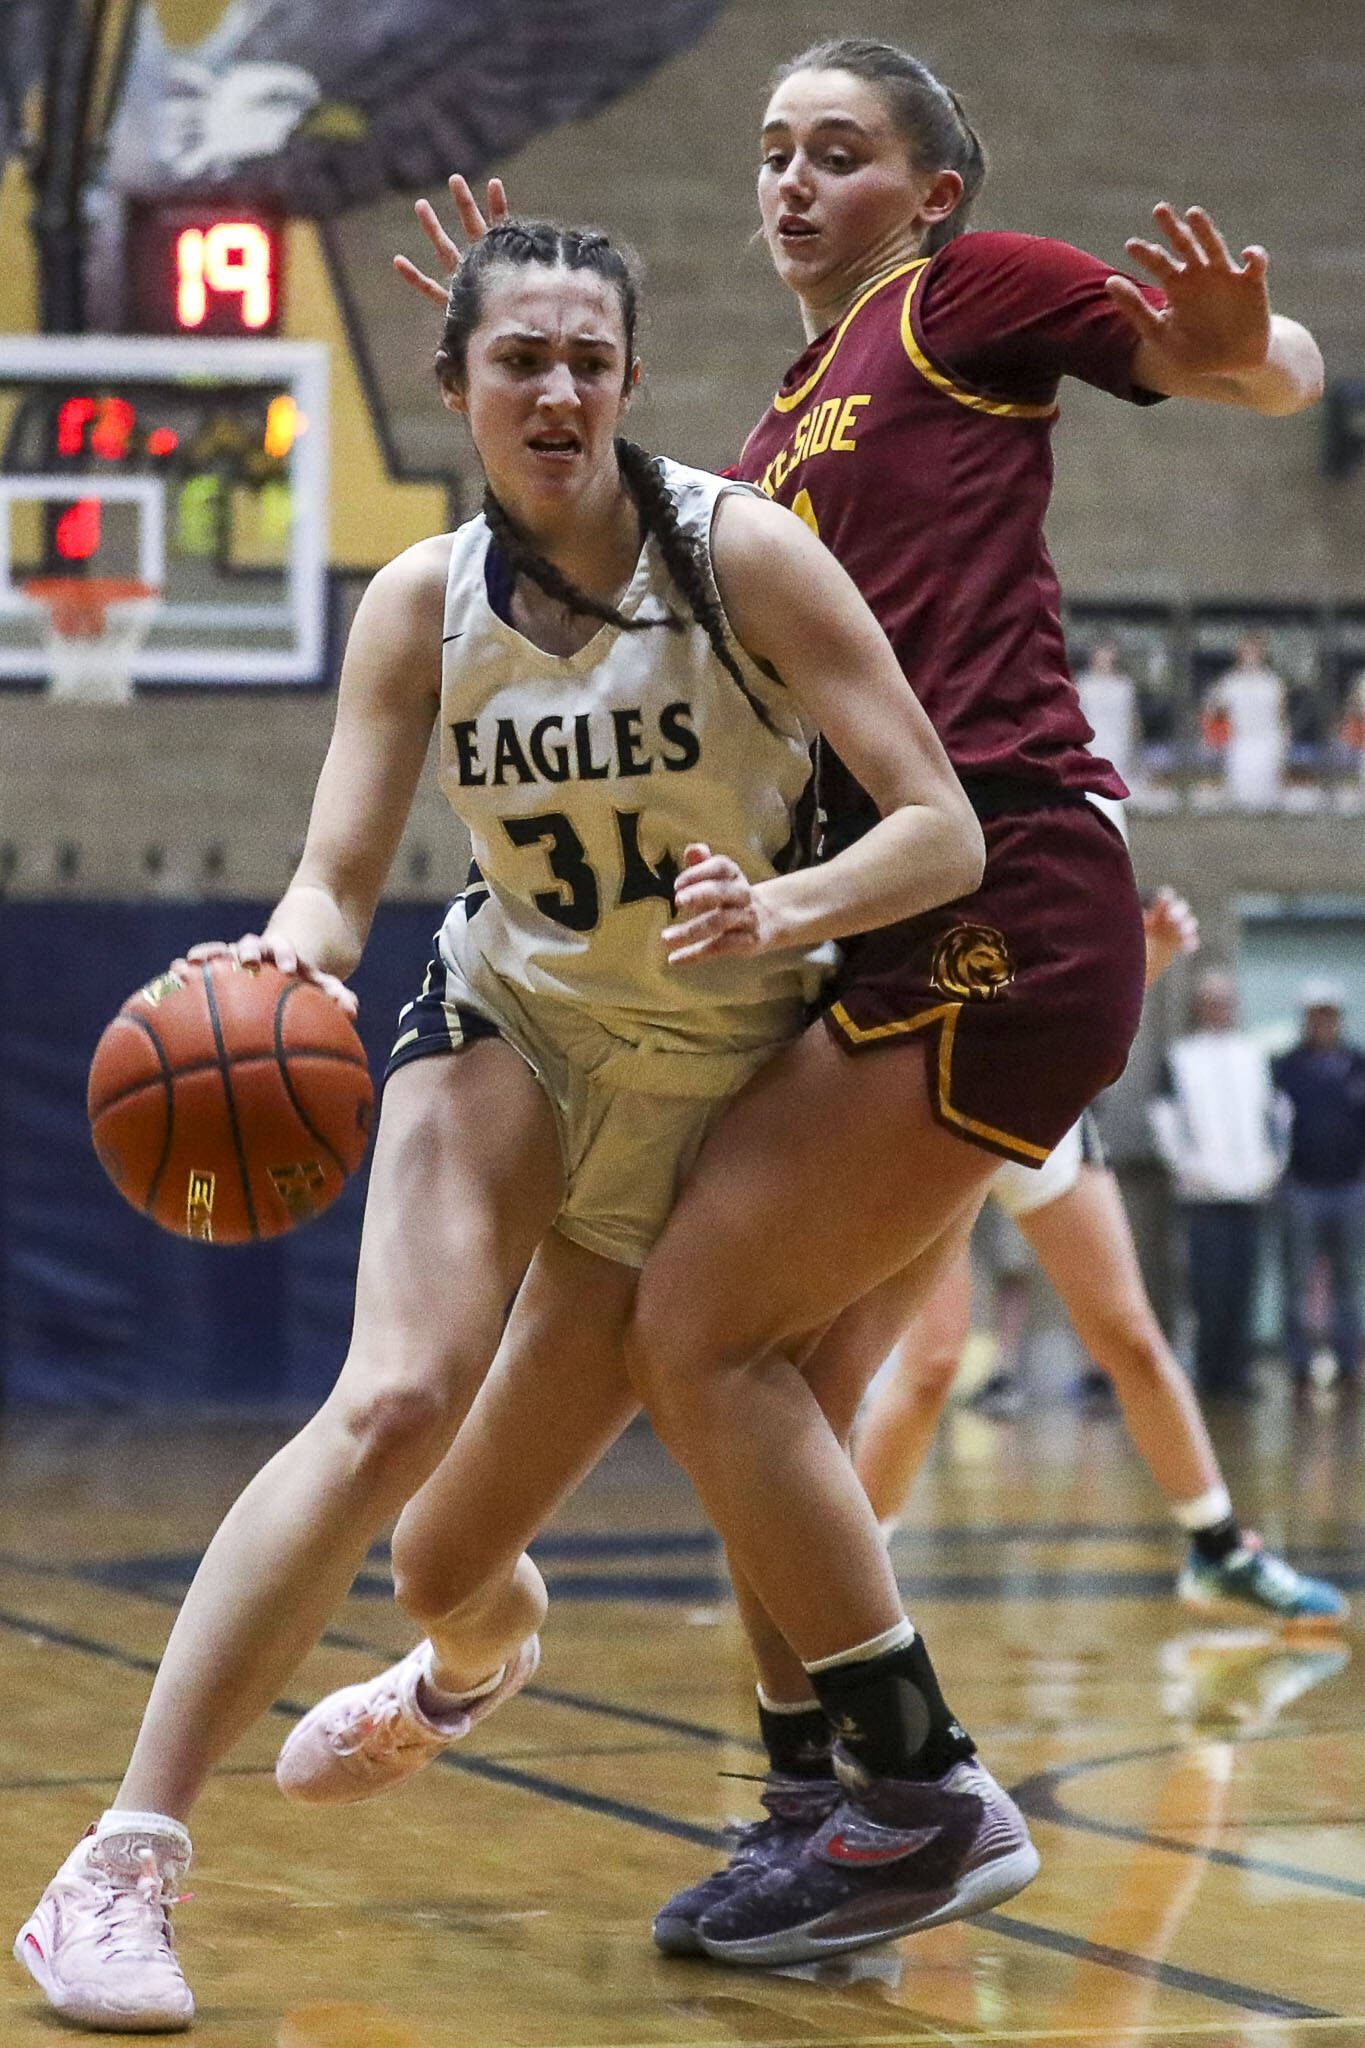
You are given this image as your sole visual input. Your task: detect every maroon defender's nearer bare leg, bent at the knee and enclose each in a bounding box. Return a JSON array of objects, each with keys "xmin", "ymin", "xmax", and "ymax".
[{"xmin": 626, "ymin": 1026, "xmax": 995, "ymax": 1663}]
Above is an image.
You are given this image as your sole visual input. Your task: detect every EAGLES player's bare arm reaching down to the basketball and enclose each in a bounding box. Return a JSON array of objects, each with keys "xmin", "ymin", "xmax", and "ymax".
[{"xmin": 192, "ymin": 535, "xmax": 450, "ymax": 1012}]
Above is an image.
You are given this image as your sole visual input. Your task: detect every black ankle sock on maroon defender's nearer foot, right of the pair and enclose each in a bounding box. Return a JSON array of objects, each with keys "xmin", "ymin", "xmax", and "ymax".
[{"xmin": 810, "ymin": 1636, "xmax": 976, "ymax": 1778}]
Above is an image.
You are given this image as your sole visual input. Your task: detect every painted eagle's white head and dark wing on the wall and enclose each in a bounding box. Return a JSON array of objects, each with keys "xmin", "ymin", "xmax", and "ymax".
[{"xmin": 102, "ymin": 0, "xmax": 724, "ymax": 217}]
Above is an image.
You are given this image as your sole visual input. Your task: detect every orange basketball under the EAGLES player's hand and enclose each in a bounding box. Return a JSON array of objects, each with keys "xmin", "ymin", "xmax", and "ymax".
[{"xmin": 86, "ymin": 958, "xmax": 375, "ymax": 1245}]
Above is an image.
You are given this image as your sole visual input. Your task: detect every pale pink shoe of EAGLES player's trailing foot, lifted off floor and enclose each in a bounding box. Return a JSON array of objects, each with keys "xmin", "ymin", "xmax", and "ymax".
[{"xmin": 274, "ymin": 1636, "xmax": 540, "ymax": 1806}]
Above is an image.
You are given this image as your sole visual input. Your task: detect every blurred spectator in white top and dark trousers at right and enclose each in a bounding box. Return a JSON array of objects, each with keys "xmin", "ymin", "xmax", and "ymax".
[{"xmin": 1150, "ymin": 971, "xmax": 1281, "ymax": 1399}]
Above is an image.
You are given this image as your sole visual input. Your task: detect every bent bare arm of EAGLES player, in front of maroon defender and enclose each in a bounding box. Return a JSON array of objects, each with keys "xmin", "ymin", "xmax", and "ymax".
[{"xmin": 665, "ymin": 492, "xmax": 984, "ymax": 961}]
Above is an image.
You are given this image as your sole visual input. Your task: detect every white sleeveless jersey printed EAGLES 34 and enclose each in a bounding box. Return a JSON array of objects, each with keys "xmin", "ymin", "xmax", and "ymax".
[{"xmin": 440, "ymin": 461, "xmax": 833, "ymax": 1064}]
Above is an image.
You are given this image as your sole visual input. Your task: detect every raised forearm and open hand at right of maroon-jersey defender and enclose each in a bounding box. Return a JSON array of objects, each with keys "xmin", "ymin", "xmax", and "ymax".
[{"xmin": 1105, "ymin": 203, "xmax": 1322, "ymax": 416}]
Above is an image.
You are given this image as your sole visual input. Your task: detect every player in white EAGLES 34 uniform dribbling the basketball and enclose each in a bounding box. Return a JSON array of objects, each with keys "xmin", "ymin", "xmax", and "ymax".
[{"xmin": 16, "ymin": 223, "xmax": 982, "ymax": 2032}]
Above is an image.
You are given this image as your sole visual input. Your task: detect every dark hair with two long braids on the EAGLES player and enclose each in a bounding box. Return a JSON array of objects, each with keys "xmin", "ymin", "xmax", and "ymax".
[{"xmin": 436, "ymin": 219, "xmax": 772, "ymax": 731}]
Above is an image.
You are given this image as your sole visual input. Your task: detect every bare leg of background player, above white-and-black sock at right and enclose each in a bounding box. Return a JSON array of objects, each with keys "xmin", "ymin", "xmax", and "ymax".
[{"xmin": 1019, "ymin": 1167, "xmax": 1222, "ymax": 1505}]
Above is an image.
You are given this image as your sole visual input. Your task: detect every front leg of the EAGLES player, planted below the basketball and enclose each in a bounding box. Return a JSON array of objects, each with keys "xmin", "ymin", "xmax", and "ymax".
[{"xmin": 115, "ymin": 1040, "xmax": 561, "ymax": 1819}]
